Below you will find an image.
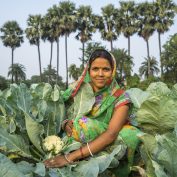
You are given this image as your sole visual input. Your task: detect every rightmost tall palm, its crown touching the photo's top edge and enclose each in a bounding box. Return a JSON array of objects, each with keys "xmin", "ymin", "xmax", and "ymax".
[{"xmin": 154, "ymin": 0, "xmax": 176, "ymax": 75}]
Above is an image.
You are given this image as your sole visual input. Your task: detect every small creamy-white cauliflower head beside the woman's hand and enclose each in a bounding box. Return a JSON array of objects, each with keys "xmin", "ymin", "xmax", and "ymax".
[{"xmin": 43, "ymin": 135, "xmax": 64, "ymax": 154}]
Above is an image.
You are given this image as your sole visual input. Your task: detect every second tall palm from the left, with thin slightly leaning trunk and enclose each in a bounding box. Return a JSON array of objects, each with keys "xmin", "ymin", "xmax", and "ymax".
[{"xmin": 25, "ymin": 15, "xmax": 42, "ymax": 81}]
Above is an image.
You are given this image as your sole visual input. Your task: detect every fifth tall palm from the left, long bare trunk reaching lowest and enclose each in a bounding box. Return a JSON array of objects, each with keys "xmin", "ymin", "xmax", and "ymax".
[{"xmin": 59, "ymin": 1, "xmax": 76, "ymax": 88}]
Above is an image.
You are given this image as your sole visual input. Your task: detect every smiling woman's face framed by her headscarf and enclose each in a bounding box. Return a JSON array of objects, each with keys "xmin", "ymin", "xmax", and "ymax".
[{"xmin": 89, "ymin": 57, "xmax": 112, "ymax": 92}]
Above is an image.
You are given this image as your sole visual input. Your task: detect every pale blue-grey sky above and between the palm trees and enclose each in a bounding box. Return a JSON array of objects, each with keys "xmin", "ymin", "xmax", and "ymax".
[{"xmin": 0, "ymin": 0, "xmax": 177, "ymax": 80}]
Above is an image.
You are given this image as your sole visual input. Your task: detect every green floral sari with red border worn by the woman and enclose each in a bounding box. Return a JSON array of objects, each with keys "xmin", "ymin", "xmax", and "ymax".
[{"xmin": 63, "ymin": 52, "xmax": 139, "ymax": 174}]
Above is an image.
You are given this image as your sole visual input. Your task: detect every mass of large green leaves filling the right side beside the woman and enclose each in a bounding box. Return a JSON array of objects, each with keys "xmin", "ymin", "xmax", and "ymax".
[{"xmin": 128, "ymin": 82, "xmax": 177, "ymax": 177}]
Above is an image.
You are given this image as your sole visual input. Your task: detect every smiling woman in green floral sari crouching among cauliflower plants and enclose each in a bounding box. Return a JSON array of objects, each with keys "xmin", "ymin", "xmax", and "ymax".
[{"xmin": 45, "ymin": 49, "xmax": 139, "ymax": 177}]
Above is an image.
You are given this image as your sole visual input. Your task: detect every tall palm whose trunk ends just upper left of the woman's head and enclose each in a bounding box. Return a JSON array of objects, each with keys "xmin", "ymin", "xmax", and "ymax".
[{"xmin": 76, "ymin": 6, "xmax": 95, "ymax": 66}]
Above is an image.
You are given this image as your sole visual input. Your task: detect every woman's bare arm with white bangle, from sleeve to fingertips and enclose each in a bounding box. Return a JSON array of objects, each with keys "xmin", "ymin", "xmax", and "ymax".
[{"xmin": 45, "ymin": 105, "xmax": 129, "ymax": 167}]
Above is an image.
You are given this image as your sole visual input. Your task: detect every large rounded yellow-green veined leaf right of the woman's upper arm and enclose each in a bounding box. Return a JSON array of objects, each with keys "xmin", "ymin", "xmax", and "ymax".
[{"xmin": 136, "ymin": 96, "xmax": 177, "ymax": 134}]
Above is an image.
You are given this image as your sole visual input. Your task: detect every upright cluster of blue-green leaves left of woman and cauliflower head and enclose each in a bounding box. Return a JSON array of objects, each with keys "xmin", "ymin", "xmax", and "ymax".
[{"xmin": 0, "ymin": 83, "xmax": 64, "ymax": 174}]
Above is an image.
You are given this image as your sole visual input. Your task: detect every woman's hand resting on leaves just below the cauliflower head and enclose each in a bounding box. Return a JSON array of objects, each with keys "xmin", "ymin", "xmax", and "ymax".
[{"xmin": 44, "ymin": 155, "xmax": 68, "ymax": 168}]
